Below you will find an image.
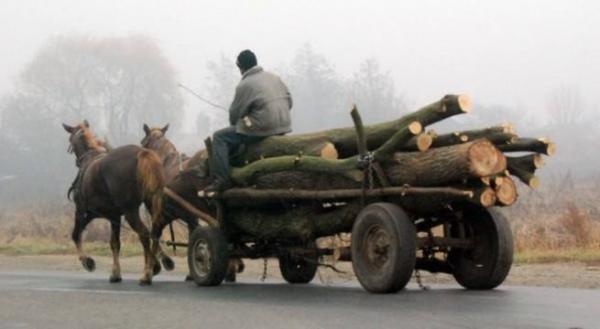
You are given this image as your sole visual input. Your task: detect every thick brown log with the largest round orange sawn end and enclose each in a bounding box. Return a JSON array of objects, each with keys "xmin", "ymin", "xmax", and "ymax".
[{"xmin": 384, "ymin": 139, "xmax": 506, "ymax": 186}]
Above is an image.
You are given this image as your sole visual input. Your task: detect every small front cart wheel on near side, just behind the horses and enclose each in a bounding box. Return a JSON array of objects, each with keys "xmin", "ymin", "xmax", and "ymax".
[{"xmin": 188, "ymin": 227, "xmax": 229, "ymax": 286}]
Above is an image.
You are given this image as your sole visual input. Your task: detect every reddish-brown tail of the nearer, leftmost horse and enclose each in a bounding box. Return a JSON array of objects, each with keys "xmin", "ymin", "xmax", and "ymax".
[{"xmin": 137, "ymin": 149, "xmax": 165, "ymax": 225}]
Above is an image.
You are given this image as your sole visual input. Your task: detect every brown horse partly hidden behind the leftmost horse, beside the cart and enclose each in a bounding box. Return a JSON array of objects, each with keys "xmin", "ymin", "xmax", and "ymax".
[{"xmin": 141, "ymin": 124, "xmax": 244, "ymax": 282}]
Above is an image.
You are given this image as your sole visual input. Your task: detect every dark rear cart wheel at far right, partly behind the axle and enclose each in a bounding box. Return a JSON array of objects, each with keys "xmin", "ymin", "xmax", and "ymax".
[{"xmin": 448, "ymin": 206, "xmax": 513, "ymax": 290}]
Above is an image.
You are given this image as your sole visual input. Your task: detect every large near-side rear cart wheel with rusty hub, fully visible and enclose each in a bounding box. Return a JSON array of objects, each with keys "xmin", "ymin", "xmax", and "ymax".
[{"xmin": 352, "ymin": 203, "xmax": 417, "ymax": 293}]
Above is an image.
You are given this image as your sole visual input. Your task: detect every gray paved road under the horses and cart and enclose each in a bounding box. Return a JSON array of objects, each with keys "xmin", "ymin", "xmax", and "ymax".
[{"xmin": 0, "ymin": 272, "xmax": 600, "ymax": 329}]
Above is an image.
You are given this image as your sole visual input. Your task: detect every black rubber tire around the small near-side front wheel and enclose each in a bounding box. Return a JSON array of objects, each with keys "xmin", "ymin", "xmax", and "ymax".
[{"xmin": 188, "ymin": 227, "xmax": 229, "ymax": 286}]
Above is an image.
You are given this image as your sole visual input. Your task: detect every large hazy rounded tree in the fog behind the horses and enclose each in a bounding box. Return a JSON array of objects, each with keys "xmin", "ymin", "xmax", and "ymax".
[{"xmin": 0, "ymin": 36, "xmax": 183, "ymax": 204}]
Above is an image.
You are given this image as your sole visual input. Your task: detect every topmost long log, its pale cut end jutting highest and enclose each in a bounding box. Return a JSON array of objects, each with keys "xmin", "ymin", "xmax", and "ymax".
[{"xmin": 233, "ymin": 95, "xmax": 471, "ymax": 166}]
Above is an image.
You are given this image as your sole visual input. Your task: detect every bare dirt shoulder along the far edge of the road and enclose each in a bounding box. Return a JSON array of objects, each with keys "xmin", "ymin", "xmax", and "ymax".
[{"xmin": 0, "ymin": 255, "xmax": 600, "ymax": 289}]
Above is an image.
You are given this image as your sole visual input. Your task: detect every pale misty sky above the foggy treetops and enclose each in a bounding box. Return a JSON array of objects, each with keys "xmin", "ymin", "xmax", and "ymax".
[{"xmin": 0, "ymin": 0, "xmax": 600, "ymax": 129}]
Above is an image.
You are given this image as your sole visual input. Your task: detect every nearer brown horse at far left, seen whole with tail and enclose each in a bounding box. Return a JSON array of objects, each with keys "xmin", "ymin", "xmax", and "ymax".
[{"xmin": 63, "ymin": 121, "xmax": 165, "ymax": 285}]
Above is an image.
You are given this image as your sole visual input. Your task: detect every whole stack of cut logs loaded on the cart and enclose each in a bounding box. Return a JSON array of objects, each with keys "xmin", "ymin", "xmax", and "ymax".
[{"xmin": 199, "ymin": 95, "xmax": 556, "ymax": 238}]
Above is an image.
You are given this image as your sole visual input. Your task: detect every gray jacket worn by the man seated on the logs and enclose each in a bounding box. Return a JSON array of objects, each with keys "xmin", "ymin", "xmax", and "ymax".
[{"xmin": 229, "ymin": 66, "xmax": 292, "ymax": 136}]
